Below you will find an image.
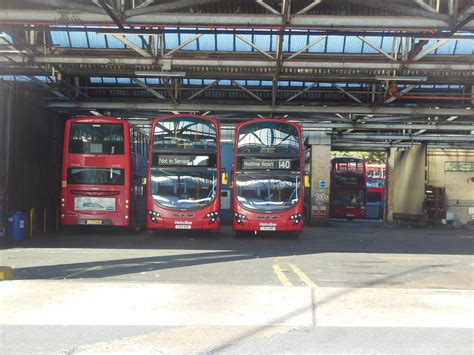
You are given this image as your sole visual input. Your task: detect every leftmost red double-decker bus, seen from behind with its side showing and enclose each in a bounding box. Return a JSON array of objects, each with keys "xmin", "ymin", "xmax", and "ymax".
[{"xmin": 60, "ymin": 116, "xmax": 148, "ymax": 228}]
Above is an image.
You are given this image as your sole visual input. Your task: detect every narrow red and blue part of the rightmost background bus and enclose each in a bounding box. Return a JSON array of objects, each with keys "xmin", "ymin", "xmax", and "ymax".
[{"xmin": 366, "ymin": 164, "xmax": 385, "ymax": 219}]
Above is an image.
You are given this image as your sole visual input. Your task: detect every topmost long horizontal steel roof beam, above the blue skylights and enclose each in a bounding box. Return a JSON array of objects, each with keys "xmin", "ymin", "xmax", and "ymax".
[{"xmin": 0, "ymin": 8, "xmax": 474, "ymax": 31}]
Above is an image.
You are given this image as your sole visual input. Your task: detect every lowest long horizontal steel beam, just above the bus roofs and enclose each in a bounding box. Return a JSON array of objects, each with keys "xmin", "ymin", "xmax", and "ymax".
[{"xmin": 47, "ymin": 100, "xmax": 473, "ymax": 116}]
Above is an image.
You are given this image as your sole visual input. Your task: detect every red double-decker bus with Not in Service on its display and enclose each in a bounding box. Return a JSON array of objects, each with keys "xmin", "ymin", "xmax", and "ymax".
[{"xmin": 147, "ymin": 114, "xmax": 220, "ymax": 230}]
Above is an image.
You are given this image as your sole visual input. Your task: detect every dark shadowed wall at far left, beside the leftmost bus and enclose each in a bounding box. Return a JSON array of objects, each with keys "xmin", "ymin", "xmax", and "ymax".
[{"xmin": 0, "ymin": 81, "xmax": 64, "ymax": 232}]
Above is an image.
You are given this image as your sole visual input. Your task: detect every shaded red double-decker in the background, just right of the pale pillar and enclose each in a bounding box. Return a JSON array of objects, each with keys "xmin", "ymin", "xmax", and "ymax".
[{"xmin": 329, "ymin": 157, "xmax": 367, "ymax": 220}]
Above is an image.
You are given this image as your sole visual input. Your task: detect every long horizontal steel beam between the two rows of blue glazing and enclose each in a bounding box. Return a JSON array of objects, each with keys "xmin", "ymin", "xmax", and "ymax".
[{"xmin": 0, "ymin": 52, "xmax": 474, "ymax": 73}]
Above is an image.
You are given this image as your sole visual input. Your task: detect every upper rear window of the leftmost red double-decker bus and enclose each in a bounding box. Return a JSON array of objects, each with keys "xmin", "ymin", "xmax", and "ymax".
[{"xmin": 68, "ymin": 122, "xmax": 124, "ymax": 154}]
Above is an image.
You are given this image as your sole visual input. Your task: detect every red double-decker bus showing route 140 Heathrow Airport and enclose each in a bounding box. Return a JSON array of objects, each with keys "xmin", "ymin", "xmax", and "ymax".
[{"xmin": 233, "ymin": 119, "xmax": 304, "ymax": 236}]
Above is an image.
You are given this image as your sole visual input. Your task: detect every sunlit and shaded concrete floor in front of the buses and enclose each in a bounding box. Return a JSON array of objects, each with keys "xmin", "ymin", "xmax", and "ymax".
[{"xmin": 0, "ymin": 221, "xmax": 474, "ymax": 354}]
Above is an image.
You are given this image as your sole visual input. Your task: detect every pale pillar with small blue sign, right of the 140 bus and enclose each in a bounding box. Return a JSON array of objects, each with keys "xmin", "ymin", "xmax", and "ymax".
[{"xmin": 308, "ymin": 130, "xmax": 331, "ymax": 226}]
